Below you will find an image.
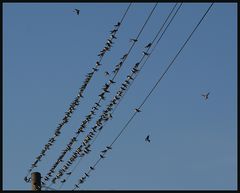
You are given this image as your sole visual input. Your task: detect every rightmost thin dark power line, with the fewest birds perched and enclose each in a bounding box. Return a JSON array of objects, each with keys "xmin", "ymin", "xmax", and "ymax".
[{"xmin": 73, "ymin": 3, "xmax": 214, "ymax": 190}]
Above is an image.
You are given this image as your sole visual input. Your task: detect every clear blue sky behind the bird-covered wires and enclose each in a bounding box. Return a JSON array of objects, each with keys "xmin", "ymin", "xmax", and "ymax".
[{"xmin": 3, "ymin": 3, "xmax": 237, "ymax": 190}]
